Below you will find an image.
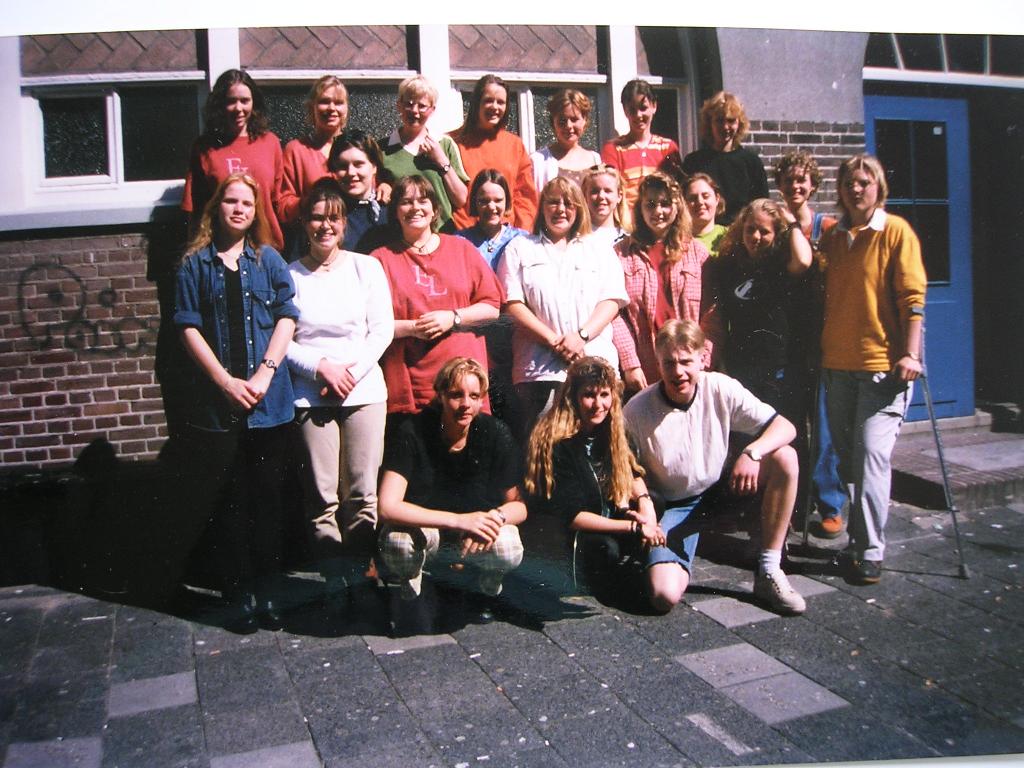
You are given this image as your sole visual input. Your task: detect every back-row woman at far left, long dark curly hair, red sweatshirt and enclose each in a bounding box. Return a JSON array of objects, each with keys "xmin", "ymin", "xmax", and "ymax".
[{"xmin": 181, "ymin": 70, "xmax": 285, "ymax": 251}]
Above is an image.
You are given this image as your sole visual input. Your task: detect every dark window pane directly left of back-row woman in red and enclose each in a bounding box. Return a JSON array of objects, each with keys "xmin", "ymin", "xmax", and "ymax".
[{"xmin": 121, "ymin": 85, "xmax": 199, "ymax": 181}]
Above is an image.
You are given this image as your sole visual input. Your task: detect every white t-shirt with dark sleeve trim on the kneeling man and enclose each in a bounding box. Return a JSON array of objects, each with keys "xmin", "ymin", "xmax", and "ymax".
[{"xmin": 623, "ymin": 372, "xmax": 775, "ymax": 501}]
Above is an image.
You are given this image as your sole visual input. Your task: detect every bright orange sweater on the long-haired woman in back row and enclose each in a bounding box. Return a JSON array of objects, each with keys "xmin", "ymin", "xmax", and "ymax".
[{"xmin": 450, "ymin": 128, "xmax": 538, "ymax": 231}]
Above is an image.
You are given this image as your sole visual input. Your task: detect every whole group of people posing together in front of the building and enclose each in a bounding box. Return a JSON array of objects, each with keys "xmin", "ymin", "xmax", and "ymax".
[{"xmin": 173, "ymin": 70, "xmax": 925, "ymax": 631}]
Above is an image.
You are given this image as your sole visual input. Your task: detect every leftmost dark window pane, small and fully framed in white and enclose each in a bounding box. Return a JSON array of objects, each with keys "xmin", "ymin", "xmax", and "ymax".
[{"xmin": 39, "ymin": 96, "xmax": 110, "ymax": 178}]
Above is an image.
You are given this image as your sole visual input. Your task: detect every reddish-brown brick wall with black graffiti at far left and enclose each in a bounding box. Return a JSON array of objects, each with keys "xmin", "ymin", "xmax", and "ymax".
[{"xmin": 0, "ymin": 233, "xmax": 167, "ymax": 468}]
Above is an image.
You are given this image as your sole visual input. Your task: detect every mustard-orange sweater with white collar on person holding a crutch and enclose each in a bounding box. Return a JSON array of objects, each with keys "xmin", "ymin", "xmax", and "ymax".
[{"xmin": 821, "ymin": 209, "xmax": 927, "ymax": 372}]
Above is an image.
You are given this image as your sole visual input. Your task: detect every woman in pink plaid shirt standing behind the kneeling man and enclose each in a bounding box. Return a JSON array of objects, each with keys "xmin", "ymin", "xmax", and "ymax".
[{"xmin": 612, "ymin": 171, "xmax": 710, "ymax": 394}]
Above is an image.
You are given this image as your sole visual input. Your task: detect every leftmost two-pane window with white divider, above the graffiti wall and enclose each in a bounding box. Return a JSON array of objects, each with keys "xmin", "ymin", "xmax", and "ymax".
[{"xmin": 34, "ymin": 83, "xmax": 199, "ymax": 187}]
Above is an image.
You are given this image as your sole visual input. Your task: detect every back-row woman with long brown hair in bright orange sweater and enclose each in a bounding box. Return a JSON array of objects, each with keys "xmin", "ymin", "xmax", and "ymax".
[{"xmin": 452, "ymin": 75, "xmax": 537, "ymax": 230}]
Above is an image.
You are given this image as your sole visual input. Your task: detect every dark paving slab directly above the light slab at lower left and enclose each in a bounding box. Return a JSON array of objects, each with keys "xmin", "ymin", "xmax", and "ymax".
[{"xmin": 111, "ymin": 607, "xmax": 195, "ymax": 683}]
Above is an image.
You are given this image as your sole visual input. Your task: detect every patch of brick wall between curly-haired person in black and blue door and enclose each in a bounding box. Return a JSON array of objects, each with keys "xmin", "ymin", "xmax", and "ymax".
[{"xmin": 744, "ymin": 120, "xmax": 864, "ymax": 212}]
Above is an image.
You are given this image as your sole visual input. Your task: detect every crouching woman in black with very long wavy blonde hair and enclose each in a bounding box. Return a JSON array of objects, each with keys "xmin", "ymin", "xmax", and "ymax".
[{"xmin": 525, "ymin": 357, "xmax": 665, "ymax": 594}]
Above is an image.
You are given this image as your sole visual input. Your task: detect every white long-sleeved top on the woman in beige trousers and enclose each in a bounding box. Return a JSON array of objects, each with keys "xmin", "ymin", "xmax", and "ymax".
[{"xmin": 288, "ymin": 251, "xmax": 394, "ymax": 408}]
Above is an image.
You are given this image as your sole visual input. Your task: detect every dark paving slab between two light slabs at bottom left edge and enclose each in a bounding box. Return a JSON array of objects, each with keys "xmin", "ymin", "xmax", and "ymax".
[{"xmin": 102, "ymin": 705, "xmax": 207, "ymax": 768}]
